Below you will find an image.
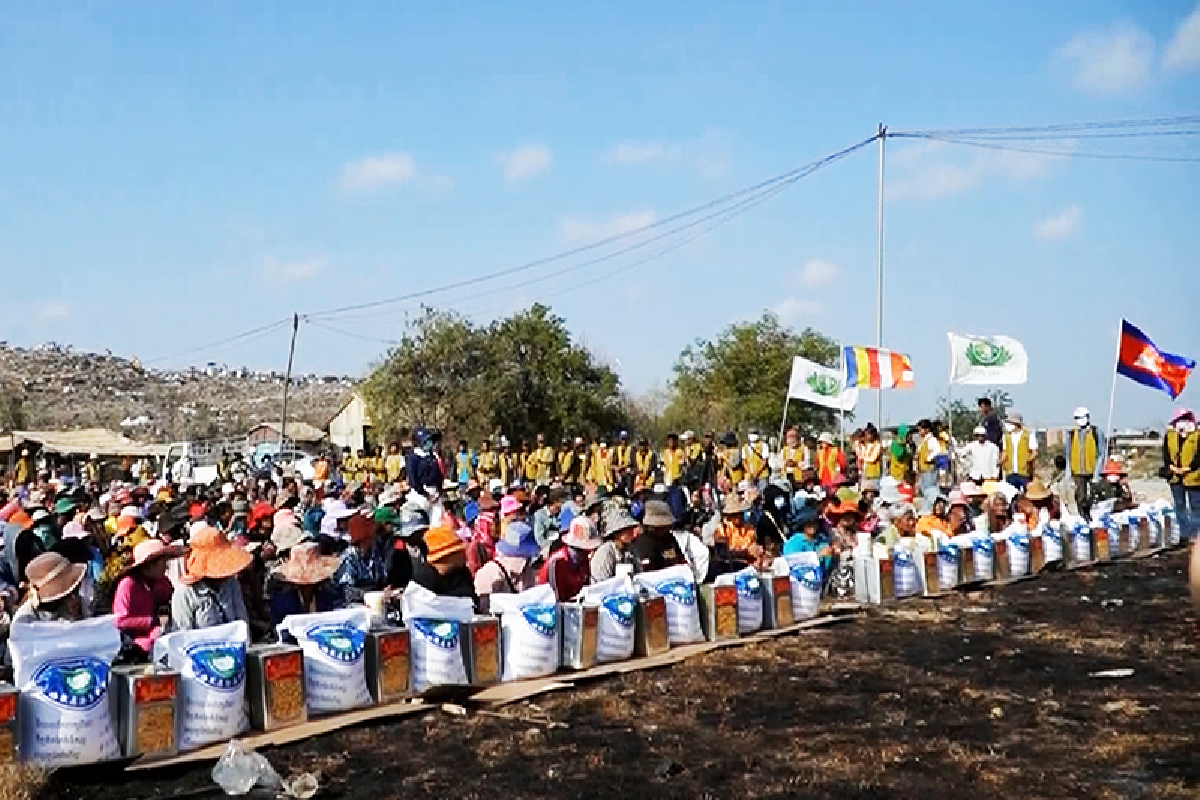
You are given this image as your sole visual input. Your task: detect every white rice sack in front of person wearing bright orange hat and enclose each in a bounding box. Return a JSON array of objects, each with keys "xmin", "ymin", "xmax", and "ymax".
[{"xmin": 403, "ymin": 583, "xmax": 477, "ymax": 693}]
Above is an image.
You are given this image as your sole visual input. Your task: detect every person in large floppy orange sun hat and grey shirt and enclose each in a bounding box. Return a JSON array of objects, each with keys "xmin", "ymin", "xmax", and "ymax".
[{"xmin": 170, "ymin": 525, "xmax": 253, "ymax": 631}]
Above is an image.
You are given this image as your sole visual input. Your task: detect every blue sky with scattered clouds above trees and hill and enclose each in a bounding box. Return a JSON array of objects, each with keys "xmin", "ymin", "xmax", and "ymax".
[{"xmin": 0, "ymin": 0, "xmax": 1200, "ymax": 425}]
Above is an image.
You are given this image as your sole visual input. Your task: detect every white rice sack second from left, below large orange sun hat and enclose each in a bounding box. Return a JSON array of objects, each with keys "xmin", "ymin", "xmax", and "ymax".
[{"xmin": 154, "ymin": 621, "xmax": 250, "ymax": 750}]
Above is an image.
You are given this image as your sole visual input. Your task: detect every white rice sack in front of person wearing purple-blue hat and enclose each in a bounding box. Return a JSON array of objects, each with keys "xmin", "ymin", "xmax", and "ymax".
[{"xmin": 491, "ymin": 584, "xmax": 562, "ymax": 680}]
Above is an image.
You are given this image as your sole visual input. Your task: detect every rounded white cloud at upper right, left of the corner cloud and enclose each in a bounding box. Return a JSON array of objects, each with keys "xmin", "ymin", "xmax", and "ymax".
[{"xmin": 1056, "ymin": 20, "xmax": 1154, "ymax": 95}]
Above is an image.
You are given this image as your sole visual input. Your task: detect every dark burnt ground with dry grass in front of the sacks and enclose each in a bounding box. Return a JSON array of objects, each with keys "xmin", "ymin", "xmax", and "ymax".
[{"xmin": 47, "ymin": 553, "xmax": 1200, "ymax": 800}]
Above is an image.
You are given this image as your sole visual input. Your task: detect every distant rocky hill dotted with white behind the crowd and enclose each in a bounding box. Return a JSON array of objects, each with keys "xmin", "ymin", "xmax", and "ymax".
[{"xmin": 0, "ymin": 343, "xmax": 354, "ymax": 441}]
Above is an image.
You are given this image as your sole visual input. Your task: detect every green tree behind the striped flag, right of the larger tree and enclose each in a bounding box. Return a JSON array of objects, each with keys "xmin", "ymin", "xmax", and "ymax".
[{"xmin": 664, "ymin": 313, "xmax": 839, "ymax": 434}]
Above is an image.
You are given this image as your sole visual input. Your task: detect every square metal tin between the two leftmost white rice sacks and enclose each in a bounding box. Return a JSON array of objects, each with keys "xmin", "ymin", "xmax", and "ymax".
[{"xmin": 108, "ymin": 664, "xmax": 180, "ymax": 758}]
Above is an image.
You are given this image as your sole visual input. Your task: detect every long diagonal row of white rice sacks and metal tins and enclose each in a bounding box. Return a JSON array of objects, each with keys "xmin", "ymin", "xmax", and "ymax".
[{"xmin": 0, "ymin": 503, "xmax": 1181, "ymax": 768}]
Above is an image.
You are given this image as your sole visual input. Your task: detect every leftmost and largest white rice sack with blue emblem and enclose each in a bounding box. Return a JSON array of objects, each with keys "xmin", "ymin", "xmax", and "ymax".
[{"xmin": 8, "ymin": 615, "xmax": 121, "ymax": 769}]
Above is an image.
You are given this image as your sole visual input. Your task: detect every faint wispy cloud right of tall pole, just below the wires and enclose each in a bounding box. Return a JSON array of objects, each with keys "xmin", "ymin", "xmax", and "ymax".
[{"xmin": 886, "ymin": 142, "xmax": 1060, "ymax": 200}]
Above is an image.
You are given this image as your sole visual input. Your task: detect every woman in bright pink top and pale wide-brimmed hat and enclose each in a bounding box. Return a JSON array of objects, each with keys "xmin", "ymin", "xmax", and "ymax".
[{"xmin": 113, "ymin": 539, "xmax": 187, "ymax": 656}]
